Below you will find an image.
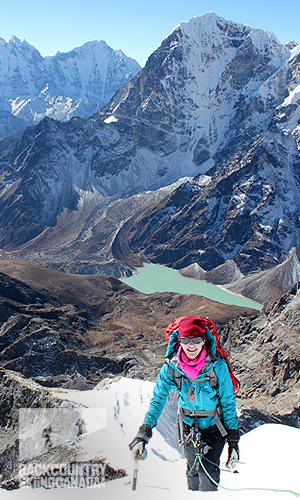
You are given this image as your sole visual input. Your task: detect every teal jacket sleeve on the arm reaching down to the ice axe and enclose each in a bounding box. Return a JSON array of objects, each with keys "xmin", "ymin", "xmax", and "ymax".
[{"xmin": 144, "ymin": 363, "xmax": 177, "ymax": 428}]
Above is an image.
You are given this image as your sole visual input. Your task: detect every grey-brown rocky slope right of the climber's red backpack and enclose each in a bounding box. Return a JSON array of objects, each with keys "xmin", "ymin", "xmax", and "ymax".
[{"xmin": 221, "ymin": 283, "xmax": 300, "ymax": 414}]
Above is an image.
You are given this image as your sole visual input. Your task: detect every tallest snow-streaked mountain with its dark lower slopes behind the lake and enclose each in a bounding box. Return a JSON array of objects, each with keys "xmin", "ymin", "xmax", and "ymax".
[{"xmin": 0, "ymin": 13, "xmax": 300, "ymax": 284}]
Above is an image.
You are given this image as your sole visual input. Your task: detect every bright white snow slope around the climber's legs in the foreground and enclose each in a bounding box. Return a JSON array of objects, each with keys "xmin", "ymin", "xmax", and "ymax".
[{"xmin": 1, "ymin": 378, "xmax": 300, "ymax": 500}]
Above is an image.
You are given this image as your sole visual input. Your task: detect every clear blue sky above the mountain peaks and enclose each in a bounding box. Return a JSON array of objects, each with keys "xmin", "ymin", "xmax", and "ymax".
[{"xmin": 0, "ymin": 0, "xmax": 300, "ymax": 66}]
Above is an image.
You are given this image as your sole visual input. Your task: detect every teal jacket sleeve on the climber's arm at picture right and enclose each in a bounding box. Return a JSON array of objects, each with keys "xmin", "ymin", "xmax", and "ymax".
[{"xmin": 215, "ymin": 359, "xmax": 238, "ymax": 430}]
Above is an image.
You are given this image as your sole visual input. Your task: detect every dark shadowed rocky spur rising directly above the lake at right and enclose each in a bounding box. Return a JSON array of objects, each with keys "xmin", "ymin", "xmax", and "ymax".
[{"xmin": 127, "ymin": 132, "xmax": 300, "ymax": 292}]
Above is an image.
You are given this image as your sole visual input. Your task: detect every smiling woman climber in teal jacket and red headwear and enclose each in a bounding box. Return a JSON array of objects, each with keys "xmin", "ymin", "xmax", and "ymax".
[{"xmin": 129, "ymin": 316, "xmax": 239, "ymax": 491}]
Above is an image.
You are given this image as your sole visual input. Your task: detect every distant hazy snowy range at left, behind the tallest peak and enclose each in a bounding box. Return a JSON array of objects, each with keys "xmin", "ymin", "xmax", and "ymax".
[{"xmin": 0, "ymin": 36, "xmax": 141, "ymax": 137}]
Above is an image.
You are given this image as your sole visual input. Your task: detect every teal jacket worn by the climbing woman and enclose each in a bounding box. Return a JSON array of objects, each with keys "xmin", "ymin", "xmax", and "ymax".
[{"xmin": 144, "ymin": 328, "xmax": 238, "ymax": 430}]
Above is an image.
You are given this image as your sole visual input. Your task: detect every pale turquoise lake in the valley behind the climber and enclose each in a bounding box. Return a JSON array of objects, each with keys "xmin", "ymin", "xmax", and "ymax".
[{"xmin": 121, "ymin": 264, "xmax": 262, "ymax": 310}]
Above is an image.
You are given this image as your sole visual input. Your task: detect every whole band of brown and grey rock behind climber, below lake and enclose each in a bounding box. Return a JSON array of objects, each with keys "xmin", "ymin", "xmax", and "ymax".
[{"xmin": 0, "ymin": 261, "xmax": 300, "ymax": 415}]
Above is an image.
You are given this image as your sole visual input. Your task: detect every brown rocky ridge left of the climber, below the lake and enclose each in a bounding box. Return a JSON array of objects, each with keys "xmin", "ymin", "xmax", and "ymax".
[{"xmin": 0, "ymin": 261, "xmax": 257, "ymax": 389}]
